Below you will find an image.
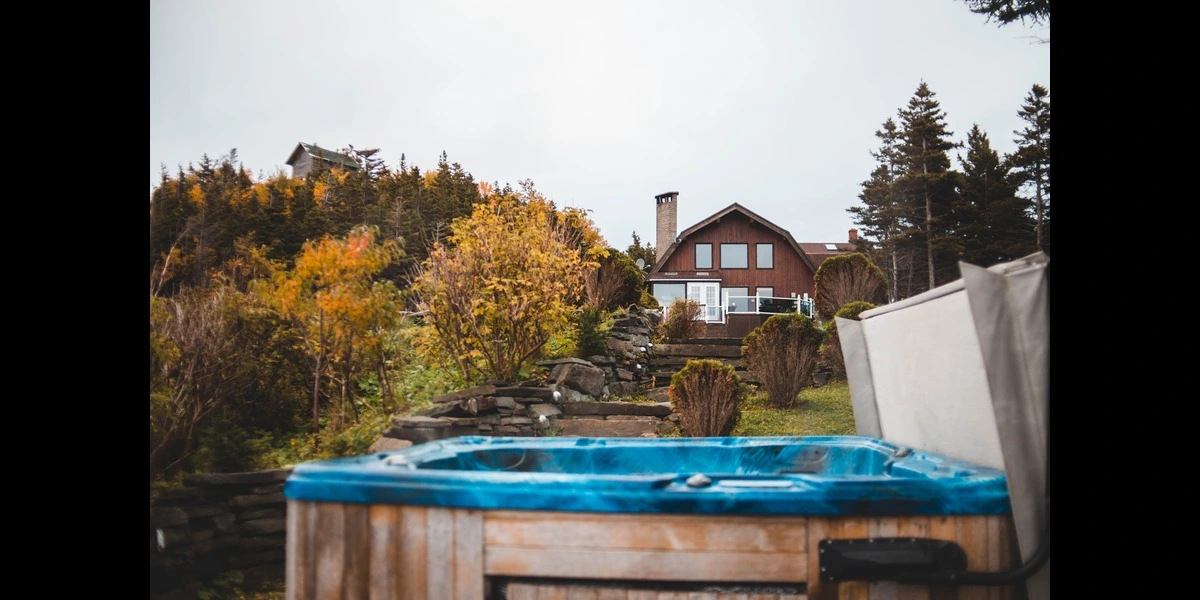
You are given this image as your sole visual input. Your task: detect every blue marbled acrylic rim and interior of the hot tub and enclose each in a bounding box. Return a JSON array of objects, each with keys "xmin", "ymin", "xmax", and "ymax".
[{"xmin": 284, "ymin": 436, "xmax": 1009, "ymax": 515}]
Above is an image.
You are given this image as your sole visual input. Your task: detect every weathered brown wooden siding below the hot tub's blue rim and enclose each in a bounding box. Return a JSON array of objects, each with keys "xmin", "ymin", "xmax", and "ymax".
[{"xmin": 287, "ymin": 500, "xmax": 1016, "ymax": 600}]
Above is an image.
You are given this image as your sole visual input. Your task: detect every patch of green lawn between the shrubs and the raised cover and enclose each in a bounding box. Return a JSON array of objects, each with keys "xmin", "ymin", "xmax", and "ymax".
[{"xmin": 733, "ymin": 382, "xmax": 854, "ymax": 436}]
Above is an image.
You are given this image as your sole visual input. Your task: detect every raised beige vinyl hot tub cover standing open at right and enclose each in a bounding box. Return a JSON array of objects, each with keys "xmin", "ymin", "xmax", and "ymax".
[{"xmin": 838, "ymin": 252, "xmax": 1050, "ymax": 600}]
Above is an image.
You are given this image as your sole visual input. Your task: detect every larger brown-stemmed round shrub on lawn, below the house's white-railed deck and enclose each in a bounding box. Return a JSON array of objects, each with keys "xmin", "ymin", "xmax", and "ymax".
[{"xmin": 742, "ymin": 313, "xmax": 824, "ymax": 408}]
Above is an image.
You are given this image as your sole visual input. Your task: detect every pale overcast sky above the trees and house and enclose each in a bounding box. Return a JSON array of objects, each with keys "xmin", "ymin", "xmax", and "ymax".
[{"xmin": 150, "ymin": 0, "xmax": 1050, "ymax": 248}]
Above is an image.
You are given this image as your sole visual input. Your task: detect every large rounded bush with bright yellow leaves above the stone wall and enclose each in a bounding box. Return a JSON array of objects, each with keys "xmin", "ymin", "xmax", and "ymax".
[{"xmin": 413, "ymin": 190, "xmax": 604, "ymax": 382}]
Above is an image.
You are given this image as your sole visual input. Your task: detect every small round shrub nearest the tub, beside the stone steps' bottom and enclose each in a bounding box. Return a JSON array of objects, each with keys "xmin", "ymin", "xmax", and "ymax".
[{"xmin": 667, "ymin": 359, "xmax": 746, "ymax": 438}]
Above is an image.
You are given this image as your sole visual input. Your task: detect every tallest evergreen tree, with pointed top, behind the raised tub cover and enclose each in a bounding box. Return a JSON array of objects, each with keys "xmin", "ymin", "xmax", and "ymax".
[{"xmin": 899, "ymin": 82, "xmax": 961, "ymax": 289}]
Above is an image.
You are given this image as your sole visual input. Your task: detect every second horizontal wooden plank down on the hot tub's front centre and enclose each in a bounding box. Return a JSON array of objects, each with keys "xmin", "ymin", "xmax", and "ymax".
[{"xmin": 484, "ymin": 546, "xmax": 808, "ymax": 582}]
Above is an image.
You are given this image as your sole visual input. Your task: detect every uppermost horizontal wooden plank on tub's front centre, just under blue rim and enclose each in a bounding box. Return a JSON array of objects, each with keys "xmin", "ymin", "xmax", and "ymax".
[{"xmin": 484, "ymin": 512, "xmax": 808, "ymax": 553}]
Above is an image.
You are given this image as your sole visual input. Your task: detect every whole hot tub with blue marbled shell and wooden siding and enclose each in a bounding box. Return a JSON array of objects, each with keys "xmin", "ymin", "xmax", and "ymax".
[{"xmin": 284, "ymin": 437, "xmax": 1014, "ymax": 599}]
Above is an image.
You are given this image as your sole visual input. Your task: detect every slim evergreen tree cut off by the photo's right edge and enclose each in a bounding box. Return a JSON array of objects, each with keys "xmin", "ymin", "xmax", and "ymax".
[{"xmin": 1010, "ymin": 84, "xmax": 1050, "ymax": 253}]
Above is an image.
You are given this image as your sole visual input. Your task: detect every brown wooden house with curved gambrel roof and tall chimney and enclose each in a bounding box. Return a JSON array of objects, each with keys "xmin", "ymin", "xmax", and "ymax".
[{"xmin": 649, "ymin": 192, "xmax": 858, "ymax": 337}]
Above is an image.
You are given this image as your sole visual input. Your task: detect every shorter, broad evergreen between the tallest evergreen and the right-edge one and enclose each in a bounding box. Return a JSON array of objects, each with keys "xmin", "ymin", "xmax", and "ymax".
[{"xmin": 959, "ymin": 125, "xmax": 1034, "ymax": 266}]
